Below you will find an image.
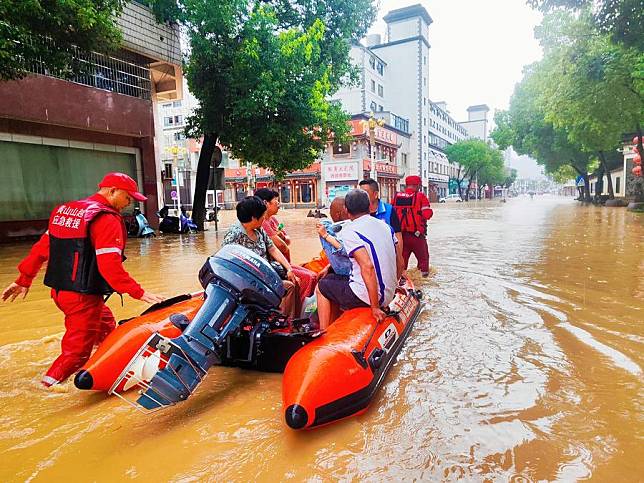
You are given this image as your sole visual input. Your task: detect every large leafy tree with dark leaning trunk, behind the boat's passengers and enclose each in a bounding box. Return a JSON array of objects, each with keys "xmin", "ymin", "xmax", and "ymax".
[{"xmin": 155, "ymin": 0, "xmax": 375, "ymax": 227}]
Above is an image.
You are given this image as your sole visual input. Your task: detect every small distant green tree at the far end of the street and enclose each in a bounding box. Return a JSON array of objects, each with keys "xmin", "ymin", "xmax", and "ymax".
[{"xmin": 445, "ymin": 139, "xmax": 503, "ymax": 201}]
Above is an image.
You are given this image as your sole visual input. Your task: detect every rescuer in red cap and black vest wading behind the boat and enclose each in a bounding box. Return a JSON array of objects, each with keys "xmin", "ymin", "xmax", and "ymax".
[{"xmin": 2, "ymin": 173, "xmax": 163, "ymax": 387}]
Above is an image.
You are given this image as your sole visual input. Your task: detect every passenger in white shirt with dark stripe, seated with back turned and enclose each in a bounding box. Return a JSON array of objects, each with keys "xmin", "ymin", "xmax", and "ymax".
[{"xmin": 316, "ymin": 189, "xmax": 403, "ymax": 329}]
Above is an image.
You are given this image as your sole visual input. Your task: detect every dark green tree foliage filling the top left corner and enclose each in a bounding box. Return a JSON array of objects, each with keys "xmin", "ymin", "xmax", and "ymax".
[{"xmin": 0, "ymin": 0, "xmax": 125, "ymax": 81}]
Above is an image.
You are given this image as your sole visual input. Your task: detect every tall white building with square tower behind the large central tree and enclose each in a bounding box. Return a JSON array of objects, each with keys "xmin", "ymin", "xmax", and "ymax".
[{"xmin": 333, "ymin": 5, "xmax": 480, "ymax": 200}]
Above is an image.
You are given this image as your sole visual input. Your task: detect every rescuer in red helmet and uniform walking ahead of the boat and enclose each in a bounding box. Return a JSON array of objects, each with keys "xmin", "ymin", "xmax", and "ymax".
[{"xmin": 393, "ymin": 176, "xmax": 434, "ymax": 277}]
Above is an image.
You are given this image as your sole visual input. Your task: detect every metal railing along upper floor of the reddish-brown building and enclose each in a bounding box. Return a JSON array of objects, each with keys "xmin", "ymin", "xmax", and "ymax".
[{"xmin": 26, "ymin": 38, "xmax": 151, "ymax": 100}]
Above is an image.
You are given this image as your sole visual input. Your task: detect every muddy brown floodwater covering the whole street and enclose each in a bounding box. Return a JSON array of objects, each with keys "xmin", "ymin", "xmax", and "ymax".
[{"xmin": 0, "ymin": 197, "xmax": 644, "ymax": 482}]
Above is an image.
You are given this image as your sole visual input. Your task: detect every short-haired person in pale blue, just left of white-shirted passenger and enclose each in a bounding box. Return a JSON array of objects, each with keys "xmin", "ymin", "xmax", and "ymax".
[{"xmin": 317, "ymin": 196, "xmax": 351, "ymax": 276}]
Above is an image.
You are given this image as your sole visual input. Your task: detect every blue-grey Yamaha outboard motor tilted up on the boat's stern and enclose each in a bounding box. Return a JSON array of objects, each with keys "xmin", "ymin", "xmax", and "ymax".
[{"xmin": 137, "ymin": 245, "xmax": 284, "ymax": 409}]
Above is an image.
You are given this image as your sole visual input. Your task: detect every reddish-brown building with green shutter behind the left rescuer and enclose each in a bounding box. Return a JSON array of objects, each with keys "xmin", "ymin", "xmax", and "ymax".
[{"xmin": 0, "ymin": 2, "xmax": 182, "ymax": 240}]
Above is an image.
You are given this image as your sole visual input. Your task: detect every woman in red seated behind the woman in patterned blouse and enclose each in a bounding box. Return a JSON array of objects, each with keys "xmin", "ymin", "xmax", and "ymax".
[{"xmin": 255, "ymin": 188, "xmax": 318, "ymax": 303}]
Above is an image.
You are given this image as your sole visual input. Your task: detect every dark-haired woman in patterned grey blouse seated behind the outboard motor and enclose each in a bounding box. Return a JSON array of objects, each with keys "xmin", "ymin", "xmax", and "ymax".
[{"xmin": 223, "ymin": 196, "xmax": 300, "ymax": 318}]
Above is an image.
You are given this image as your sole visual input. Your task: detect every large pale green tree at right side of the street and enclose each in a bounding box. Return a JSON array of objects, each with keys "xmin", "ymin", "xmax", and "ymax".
[{"xmin": 491, "ymin": 11, "xmax": 644, "ymax": 200}]
